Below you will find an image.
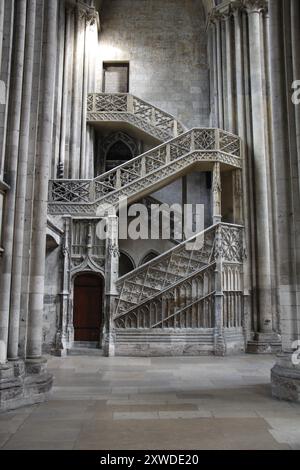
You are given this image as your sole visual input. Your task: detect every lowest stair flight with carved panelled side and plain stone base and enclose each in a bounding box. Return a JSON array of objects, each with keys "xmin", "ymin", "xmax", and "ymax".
[{"xmin": 113, "ymin": 223, "xmax": 244, "ymax": 355}]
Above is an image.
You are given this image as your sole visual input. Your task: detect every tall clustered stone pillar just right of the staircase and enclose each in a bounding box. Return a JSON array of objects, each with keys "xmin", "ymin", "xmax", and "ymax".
[{"xmin": 210, "ymin": 0, "xmax": 281, "ymax": 352}]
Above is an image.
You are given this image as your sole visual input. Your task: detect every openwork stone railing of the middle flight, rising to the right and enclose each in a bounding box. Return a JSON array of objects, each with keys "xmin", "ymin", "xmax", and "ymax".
[{"xmin": 49, "ymin": 128, "xmax": 241, "ymax": 213}]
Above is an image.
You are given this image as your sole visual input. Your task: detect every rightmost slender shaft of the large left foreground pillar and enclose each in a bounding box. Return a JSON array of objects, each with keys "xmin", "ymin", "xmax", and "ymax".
[{"xmin": 27, "ymin": 0, "xmax": 58, "ymax": 359}]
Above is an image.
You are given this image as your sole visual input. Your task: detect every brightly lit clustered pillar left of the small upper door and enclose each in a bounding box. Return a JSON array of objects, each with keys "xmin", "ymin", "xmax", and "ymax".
[{"xmin": 54, "ymin": 2, "xmax": 98, "ymax": 179}]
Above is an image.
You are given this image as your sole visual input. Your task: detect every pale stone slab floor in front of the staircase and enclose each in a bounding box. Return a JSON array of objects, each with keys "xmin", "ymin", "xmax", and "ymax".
[{"xmin": 0, "ymin": 355, "xmax": 300, "ymax": 450}]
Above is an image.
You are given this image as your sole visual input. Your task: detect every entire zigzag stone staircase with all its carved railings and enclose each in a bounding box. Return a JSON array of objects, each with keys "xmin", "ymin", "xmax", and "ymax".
[{"xmin": 48, "ymin": 94, "xmax": 244, "ymax": 355}]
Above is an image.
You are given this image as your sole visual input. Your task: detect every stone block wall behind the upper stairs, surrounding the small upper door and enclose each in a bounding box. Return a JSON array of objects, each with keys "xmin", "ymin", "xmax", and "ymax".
[{"xmin": 98, "ymin": 0, "xmax": 209, "ymax": 127}]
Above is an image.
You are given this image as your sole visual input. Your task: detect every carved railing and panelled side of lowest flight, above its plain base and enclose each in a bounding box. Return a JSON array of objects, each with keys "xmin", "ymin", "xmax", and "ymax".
[{"xmin": 114, "ymin": 223, "xmax": 244, "ymax": 334}]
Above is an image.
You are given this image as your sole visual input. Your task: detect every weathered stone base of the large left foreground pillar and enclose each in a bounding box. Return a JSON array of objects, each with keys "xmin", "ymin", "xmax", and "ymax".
[{"xmin": 0, "ymin": 358, "xmax": 53, "ymax": 412}]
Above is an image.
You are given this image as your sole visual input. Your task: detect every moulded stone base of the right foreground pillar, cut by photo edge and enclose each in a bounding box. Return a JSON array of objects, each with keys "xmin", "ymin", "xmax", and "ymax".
[{"xmin": 271, "ymin": 351, "xmax": 300, "ymax": 403}]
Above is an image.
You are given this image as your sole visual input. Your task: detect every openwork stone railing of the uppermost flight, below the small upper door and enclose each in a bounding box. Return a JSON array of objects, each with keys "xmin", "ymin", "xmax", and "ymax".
[{"xmin": 87, "ymin": 93, "xmax": 185, "ymax": 140}]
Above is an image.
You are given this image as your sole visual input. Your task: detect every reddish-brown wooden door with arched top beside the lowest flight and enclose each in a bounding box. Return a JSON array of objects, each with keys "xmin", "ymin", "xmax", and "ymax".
[{"xmin": 73, "ymin": 273, "xmax": 103, "ymax": 342}]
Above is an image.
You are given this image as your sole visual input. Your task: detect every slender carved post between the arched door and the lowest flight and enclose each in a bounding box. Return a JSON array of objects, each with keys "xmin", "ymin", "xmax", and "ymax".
[{"xmin": 103, "ymin": 215, "xmax": 119, "ymax": 356}]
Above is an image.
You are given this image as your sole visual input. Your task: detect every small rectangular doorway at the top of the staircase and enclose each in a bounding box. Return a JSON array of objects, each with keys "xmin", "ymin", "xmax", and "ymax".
[{"xmin": 103, "ymin": 62, "xmax": 129, "ymax": 93}]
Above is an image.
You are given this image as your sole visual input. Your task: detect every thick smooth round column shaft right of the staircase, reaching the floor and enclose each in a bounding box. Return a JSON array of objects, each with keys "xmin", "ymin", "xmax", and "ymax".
[{"xmin": 245, "ymin": 0, "xmax": 279, "ymax": 352}]
